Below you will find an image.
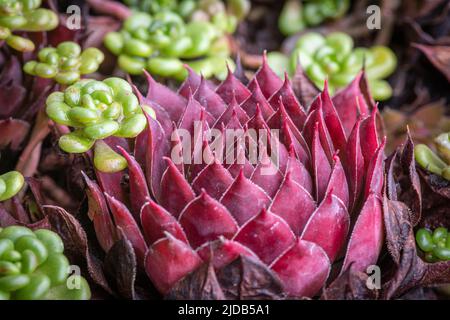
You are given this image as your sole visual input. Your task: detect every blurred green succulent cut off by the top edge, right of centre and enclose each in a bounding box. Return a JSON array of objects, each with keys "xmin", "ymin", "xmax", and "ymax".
[{"xmin": 278, "ymin": 0, "xmax": 350, "ymax": 36}]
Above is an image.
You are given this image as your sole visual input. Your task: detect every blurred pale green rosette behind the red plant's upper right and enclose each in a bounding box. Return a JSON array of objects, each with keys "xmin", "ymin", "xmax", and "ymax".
[{"xmin": 269, "ymin": 32, "xmax": 397, "ymax": 100}]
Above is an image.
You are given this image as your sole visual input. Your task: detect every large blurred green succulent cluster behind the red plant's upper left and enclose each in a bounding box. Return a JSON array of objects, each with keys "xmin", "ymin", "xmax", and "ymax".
[{"xmin": 104, "ymin": 1, "xmax": 248, "ymax": 80}]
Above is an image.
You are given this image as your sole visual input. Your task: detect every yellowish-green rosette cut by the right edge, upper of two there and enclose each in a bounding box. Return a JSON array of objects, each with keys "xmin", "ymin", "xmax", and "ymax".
[{"xmin": 414, "ymin": 133, "xmax": 450, "ymax": 181}]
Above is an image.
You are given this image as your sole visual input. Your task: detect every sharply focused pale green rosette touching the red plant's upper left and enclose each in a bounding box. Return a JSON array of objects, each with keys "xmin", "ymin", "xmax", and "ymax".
[{"xmin": 46, "ymin": 77, "xmax": 147, "ymax": 153}]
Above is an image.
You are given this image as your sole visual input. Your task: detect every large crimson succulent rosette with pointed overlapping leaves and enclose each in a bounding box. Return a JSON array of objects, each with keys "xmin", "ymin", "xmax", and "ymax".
[{"xmin": 82, "ymin": 61, "xmax": 385, "ymax": 298}]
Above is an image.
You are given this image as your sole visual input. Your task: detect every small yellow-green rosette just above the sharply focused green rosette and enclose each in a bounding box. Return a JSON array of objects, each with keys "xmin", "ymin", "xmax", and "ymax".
[{"xmin": 23, "ymin": 41, "xmax": 105, "ymax": 85}]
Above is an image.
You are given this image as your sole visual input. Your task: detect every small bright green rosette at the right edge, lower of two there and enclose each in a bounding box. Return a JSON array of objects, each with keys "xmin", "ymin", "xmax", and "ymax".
[{"xmin": 416, "ymin": 227, "xmax": 450, "ymax": 262}]
